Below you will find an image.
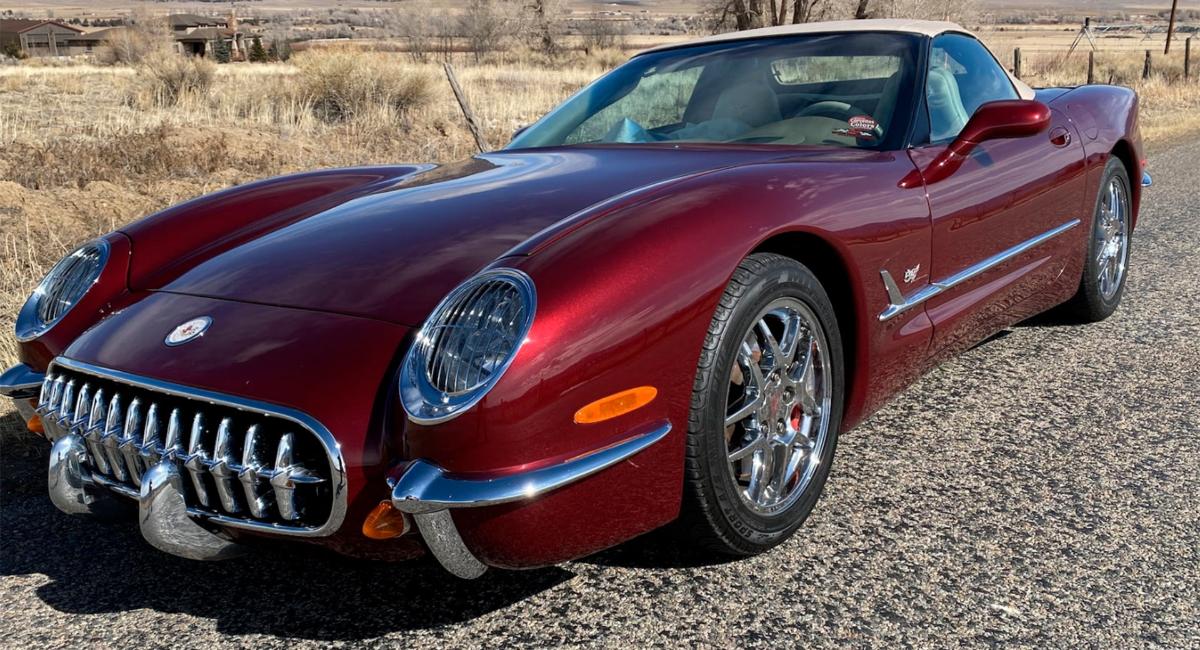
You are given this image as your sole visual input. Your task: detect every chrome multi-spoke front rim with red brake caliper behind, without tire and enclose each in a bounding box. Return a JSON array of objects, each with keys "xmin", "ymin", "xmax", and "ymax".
[{"xmin": 725, "ymin": 297, "xmax": 833, "ymax": 516}]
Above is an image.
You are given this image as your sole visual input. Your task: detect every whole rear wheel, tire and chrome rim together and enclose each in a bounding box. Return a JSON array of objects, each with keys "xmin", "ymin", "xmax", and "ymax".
[{"xmin": 1068, "ymin": 156, "xmax": 1133, "ymax": 323}]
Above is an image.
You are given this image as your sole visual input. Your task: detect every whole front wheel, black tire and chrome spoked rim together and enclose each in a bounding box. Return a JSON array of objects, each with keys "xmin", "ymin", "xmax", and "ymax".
[{"xmin": 683, "ymin": 253, "xmax": 844, "ymax": 555}]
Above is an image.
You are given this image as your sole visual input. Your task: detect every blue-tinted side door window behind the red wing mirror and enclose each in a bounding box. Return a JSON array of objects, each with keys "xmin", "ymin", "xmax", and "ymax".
[{"xmin": 925, "ymin": 34, "xmax": 1018, "ymax": 143}]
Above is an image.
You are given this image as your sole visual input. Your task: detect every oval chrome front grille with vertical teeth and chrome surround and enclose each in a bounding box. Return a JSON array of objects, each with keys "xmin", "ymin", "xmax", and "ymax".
[{"xmin": 37, "ymin": 359, "xmax": 346, "ymax": 535}]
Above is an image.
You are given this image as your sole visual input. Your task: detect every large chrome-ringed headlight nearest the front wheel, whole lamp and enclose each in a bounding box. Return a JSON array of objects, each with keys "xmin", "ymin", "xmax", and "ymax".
[{"xmin": 400, "ymin": 269, "xmax": 536, "ymax": 425}]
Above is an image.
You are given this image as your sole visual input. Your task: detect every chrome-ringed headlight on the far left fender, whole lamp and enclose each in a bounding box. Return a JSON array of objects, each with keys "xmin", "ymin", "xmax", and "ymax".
[{"xmin": 17, "ymin": 240, "xmax": 108, "ymax": 341}]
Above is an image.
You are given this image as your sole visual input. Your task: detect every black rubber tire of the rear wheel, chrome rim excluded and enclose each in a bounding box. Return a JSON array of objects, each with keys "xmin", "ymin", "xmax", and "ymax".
[{"xmin": 1064, "ymin": 156, "xmax": 1133, "ymax": 323}]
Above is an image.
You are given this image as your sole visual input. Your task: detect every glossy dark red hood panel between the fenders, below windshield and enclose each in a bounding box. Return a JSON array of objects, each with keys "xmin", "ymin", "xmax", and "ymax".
[{"xmin": 150, "ymin": 146, "xmax": 782, "ymax": 325}]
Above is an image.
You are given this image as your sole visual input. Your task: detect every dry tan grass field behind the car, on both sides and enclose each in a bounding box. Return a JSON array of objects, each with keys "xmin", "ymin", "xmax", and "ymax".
[{"xmin": 0, "ymin": 31, "xmax": 1200, "ymax": 381}]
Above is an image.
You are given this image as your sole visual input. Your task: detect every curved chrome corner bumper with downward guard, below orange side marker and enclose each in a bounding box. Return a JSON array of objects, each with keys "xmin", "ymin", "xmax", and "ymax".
[{"xmin": 391, "ymin": 422, "xmax": 671, "ymax": 579}]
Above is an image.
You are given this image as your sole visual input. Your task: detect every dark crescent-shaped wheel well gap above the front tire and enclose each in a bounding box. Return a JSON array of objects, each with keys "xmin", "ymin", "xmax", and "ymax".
[{"xmin": 754, "ymin": 233, "xmax": 859, "ymax": 422}]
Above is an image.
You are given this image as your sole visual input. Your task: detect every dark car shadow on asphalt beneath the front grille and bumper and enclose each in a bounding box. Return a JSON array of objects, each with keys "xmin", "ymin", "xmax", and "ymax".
[{"xmin": 0, "ymin": 414, "xmax": 574, "ymax": 642}]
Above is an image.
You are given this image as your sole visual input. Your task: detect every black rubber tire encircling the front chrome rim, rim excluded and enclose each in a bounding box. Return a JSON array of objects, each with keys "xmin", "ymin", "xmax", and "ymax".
[{"xmin": 680, "ymin": 253, "xmax": 845, "ymax": 555}]
